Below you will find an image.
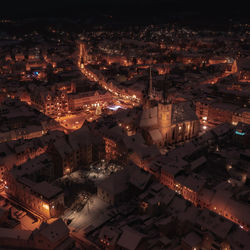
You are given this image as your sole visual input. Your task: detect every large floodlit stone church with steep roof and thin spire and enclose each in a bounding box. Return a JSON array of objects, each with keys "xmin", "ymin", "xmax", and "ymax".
[{"xmin": 140, "ymin": 68, "xmax": 200, "ymax": 147}]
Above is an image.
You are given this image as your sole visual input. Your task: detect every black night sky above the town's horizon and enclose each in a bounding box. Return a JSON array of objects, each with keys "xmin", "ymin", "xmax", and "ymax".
[{"xmin": 0, "ymin": 0, "xmax": 249, "ymax": 22}]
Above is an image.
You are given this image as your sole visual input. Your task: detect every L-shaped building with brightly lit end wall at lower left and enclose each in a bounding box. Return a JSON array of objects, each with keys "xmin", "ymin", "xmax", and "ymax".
[{"xmin": 4, "ymin": 154, "xmax": 64, "ymax": 218}]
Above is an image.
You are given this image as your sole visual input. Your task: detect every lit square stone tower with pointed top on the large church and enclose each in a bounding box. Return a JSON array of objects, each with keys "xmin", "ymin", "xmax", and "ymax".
[{"xmin": 157, "ymin": 85, "xmax": 172, "ymax": 140}]
